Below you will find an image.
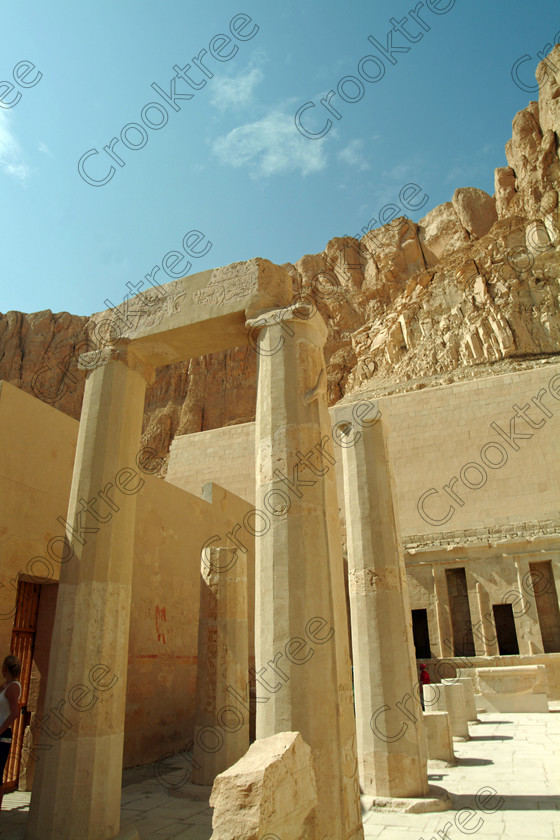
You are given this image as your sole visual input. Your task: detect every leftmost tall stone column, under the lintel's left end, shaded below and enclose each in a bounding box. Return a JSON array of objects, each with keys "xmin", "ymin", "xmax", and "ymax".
[{"xmin": 26, "ymin": 345, "xmax": 151, "ymax": 840}]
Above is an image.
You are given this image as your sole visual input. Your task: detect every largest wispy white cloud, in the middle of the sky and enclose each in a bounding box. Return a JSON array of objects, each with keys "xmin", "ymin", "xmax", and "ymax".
[{"xmin": 212, "ymin": 110, "xmax": 327, "ymax": 178}]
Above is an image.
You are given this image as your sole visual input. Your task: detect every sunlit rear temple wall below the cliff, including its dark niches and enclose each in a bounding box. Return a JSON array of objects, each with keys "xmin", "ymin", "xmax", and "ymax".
[{"xmin": 167, "ymin": 364, "xmax": 560, "ymax": 697}]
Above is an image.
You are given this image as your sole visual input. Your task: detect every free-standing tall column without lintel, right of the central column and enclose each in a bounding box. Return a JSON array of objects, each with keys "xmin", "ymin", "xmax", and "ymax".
[{"xmin": 335, "ymin": 403, "xmax": 429, "ymax": 798}]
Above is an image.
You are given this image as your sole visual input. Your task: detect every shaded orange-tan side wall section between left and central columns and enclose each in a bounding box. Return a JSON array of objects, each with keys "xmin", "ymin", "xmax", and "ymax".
[{"xmin": 124, "ymin": 477, "xmax": 254, "ymax": 766}]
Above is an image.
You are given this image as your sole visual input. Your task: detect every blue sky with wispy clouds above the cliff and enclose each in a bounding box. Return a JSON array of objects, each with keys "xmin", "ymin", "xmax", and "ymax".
[{"xmin": 0, "ymin": 0, "xmax": 560, "ymax": 315}]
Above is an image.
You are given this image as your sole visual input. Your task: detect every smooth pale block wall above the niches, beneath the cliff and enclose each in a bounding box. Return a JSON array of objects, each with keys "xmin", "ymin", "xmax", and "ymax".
[{"xmin": 167, "ymin": 360, "xmax": 560, "ymax": 541}]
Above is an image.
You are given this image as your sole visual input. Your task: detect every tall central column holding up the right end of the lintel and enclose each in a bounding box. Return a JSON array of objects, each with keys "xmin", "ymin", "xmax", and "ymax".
[{"xmin": 247, "ymin": 303, "xmax": 363, "ymax": 840}]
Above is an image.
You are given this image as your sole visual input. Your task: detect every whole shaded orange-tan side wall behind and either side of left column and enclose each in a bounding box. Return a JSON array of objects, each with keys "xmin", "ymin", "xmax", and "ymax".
[{"xmin": 0, "ymin": 382, "xmax": 254, "ymax": 766}]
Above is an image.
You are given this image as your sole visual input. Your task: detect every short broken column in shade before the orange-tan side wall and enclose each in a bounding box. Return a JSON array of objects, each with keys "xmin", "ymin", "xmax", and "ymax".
[{"xmin": 192, "ymin": 546, "xmax": 249, "ymax": 785}]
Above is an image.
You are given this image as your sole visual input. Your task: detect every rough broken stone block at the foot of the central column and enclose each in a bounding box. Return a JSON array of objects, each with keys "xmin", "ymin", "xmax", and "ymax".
[{"xmin": 210, "ymin": 732, "xmax": 317, "ymax": 840}]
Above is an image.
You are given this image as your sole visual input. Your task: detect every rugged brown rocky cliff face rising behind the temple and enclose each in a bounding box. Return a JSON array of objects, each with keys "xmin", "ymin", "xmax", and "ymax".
[{"xmin": 0, "ymin": 46, "xmax": 560, "ymax": 470}]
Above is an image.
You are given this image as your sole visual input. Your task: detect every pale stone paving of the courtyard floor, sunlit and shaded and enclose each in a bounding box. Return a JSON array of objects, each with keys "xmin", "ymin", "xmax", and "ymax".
[{"xmin": 0, "ymin": 709, "xmax": 560, "ymax": 840}]
